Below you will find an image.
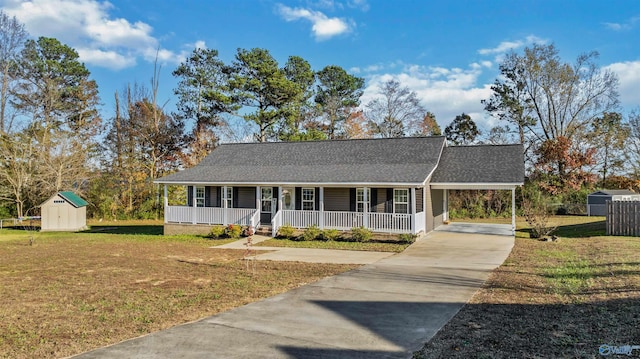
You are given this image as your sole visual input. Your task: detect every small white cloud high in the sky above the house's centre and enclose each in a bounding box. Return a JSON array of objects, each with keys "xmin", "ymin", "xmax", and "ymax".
[{"xmin": 278, "ymin": 4, "xmax": 353, "ymax": 41}]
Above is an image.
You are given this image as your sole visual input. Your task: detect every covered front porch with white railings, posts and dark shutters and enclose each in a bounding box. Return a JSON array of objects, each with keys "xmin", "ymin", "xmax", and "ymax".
[{"xmin": 164, "ymin": 184, "xmax": 426, "ymax": 236}]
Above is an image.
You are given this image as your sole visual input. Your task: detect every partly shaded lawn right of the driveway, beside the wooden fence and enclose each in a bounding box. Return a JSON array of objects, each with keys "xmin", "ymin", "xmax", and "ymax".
[{"xmin": 414, "ymin": 217, "xmax": 640, "ymax": 358}]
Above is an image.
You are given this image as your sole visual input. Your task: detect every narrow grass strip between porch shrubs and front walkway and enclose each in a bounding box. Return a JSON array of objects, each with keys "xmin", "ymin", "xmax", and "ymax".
[{"xmin": 255, "ymin": 239, "xmax": 409, "ymax": 253}]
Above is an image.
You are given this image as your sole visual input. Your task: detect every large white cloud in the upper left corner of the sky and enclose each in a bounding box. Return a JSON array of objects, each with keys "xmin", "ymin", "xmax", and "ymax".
[{"xmin": 0, "ymin": 0, "xmax": 181, "ymax": 70}]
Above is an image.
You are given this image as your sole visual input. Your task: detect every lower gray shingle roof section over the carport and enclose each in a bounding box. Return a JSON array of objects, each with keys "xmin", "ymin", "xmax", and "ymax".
[{"xmin": 431, "ymin": 145, "xmax": 524, "ymax": 183}]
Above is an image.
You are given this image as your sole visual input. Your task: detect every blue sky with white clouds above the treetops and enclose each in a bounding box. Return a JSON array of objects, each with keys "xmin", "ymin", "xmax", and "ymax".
[{"xmin": 0, "ymin": 0, "xmax": 640, "ymax": 134}]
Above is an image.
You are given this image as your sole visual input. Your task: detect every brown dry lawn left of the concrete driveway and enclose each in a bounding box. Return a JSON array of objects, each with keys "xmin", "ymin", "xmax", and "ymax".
[{"xmin": 0, "ymin": 230, "xmax": 356, "ymax": 358}]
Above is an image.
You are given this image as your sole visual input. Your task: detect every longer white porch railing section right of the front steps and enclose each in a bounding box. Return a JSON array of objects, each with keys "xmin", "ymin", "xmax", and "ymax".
[{"xmin": 271, "ymin": 210, "xmax": 425, "ymax": 236}]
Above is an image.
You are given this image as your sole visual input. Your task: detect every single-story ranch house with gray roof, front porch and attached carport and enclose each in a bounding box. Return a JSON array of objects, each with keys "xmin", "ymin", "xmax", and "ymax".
[{"xmin": 156, "ymin": 137, "xmax": 524, "ymax": 235}]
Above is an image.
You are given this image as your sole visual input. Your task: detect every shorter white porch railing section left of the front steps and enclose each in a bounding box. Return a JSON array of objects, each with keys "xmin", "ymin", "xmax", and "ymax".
[{"xmin": 164, "ymin": 206, "xmax": 260, "ymax": 227}]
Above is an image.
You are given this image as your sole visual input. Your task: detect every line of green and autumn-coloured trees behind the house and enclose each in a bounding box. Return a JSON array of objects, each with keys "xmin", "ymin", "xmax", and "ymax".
[{"xmin": 0, "ymin": 11, "xmax": 640, "ymax": 219}]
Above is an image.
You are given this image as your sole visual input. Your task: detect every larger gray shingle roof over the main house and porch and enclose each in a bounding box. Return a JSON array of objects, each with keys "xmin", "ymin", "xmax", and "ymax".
[{"xmin": 157, "ymin": 137, "xmax": 445, "ymax": 184}]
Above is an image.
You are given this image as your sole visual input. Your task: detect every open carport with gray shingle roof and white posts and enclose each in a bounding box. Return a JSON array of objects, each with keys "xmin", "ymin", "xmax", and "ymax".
[{"xmin": 430, "ymin": 145, "xmax": 524, "ymax": 235}]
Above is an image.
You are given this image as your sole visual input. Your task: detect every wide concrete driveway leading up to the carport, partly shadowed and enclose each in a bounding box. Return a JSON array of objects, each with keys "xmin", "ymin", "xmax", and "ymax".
[{"xmin": 77, "ymin": 225, "xmax": 514, "ymax": 358}]
